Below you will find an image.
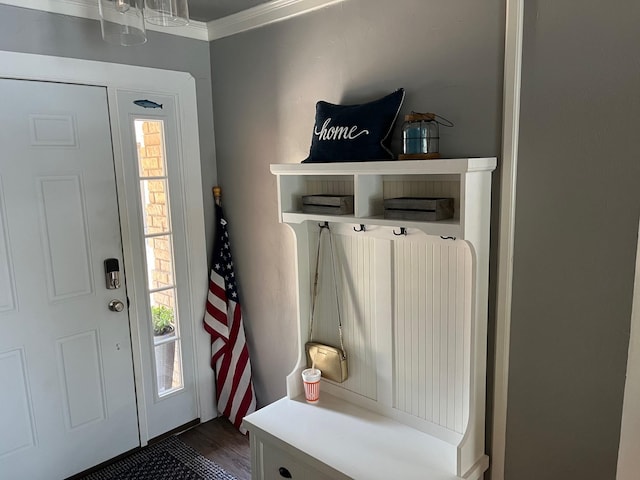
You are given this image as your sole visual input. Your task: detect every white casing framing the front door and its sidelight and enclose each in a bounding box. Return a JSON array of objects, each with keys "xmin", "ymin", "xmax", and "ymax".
[{"xmin": 0, "ymin": 50, "xmax": 217, "ymax": 438}]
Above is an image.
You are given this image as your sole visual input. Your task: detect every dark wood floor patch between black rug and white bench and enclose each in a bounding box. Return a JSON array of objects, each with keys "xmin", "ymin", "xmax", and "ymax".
[{"xmin": 178, "ymin": 417, "xmax": 251, "ymax": 480}]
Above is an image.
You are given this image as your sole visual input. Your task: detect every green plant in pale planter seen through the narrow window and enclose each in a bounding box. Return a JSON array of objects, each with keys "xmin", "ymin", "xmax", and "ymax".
[{"xmin": 151, "ymin": 305, "xmax": 176, "ymax": 393}]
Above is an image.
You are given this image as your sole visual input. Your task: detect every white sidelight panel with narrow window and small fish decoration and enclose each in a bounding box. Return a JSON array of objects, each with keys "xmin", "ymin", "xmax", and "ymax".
[{"xmin": 117, "ymin": 90, "xmax": 199, "ymax": 439}]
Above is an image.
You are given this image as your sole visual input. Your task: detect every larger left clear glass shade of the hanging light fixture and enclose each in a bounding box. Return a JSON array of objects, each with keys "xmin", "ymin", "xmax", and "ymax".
[{"xmin": 98, "ymin": 0, "xmax": 147, "ymax": 46}]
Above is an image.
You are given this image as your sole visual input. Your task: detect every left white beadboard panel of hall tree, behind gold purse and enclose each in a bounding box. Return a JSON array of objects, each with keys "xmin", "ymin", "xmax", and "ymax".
[{"xmin": 312, "ymin": 233, "xmax": 377, "ymax": 400}]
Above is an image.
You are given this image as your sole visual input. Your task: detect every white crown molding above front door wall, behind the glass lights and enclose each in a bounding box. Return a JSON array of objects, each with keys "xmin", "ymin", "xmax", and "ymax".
[{"xmin": 0, "ymin": 0, "xmax": 209, "ymax": 41}]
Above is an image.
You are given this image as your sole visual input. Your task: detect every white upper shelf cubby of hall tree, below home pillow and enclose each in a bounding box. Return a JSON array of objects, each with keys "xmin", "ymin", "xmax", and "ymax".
[{"xmin": 271, "ymin": 158, "xmax": 496, "ymax": 239}]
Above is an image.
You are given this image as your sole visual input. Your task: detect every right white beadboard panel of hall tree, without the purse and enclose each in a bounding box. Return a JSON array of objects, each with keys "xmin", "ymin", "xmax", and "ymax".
[{"xmin": 393, "ymin": 238, "xmax": 472, "ymax": 433}]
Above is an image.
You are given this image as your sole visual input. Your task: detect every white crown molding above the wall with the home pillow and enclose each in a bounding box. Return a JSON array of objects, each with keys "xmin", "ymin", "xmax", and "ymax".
[{"xmin": 207, "ymin": 0, "xmax": 345, "ymax": 40}]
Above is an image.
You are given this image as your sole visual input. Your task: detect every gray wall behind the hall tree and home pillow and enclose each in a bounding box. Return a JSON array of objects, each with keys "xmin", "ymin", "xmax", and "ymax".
[{"xmin": 211, "ymin": 0, "xmax": 504, "ymax": 405}]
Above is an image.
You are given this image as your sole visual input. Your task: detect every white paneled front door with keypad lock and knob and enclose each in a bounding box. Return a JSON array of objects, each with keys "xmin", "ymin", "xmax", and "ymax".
[{"xmin": 0, "ymin": 79, "xmax": 140, "ymax": 480}]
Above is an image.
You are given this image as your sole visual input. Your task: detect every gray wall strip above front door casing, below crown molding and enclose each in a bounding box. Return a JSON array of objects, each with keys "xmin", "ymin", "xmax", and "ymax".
[{"xmin": 0, "ymin": 5, "xmax": 217, "ymax": 251}]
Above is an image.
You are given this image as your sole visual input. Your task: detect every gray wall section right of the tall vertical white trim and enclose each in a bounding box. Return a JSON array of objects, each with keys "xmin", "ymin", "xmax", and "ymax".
[{"xmin": 506, "ymin": 0, "xmax": 640, "ymax": 480}]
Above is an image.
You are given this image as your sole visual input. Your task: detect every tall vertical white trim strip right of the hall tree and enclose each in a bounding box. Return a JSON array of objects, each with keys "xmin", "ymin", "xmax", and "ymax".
[{"xmin": 491, "ymin": 0, "xmax": 524, "ymax": 480}]
